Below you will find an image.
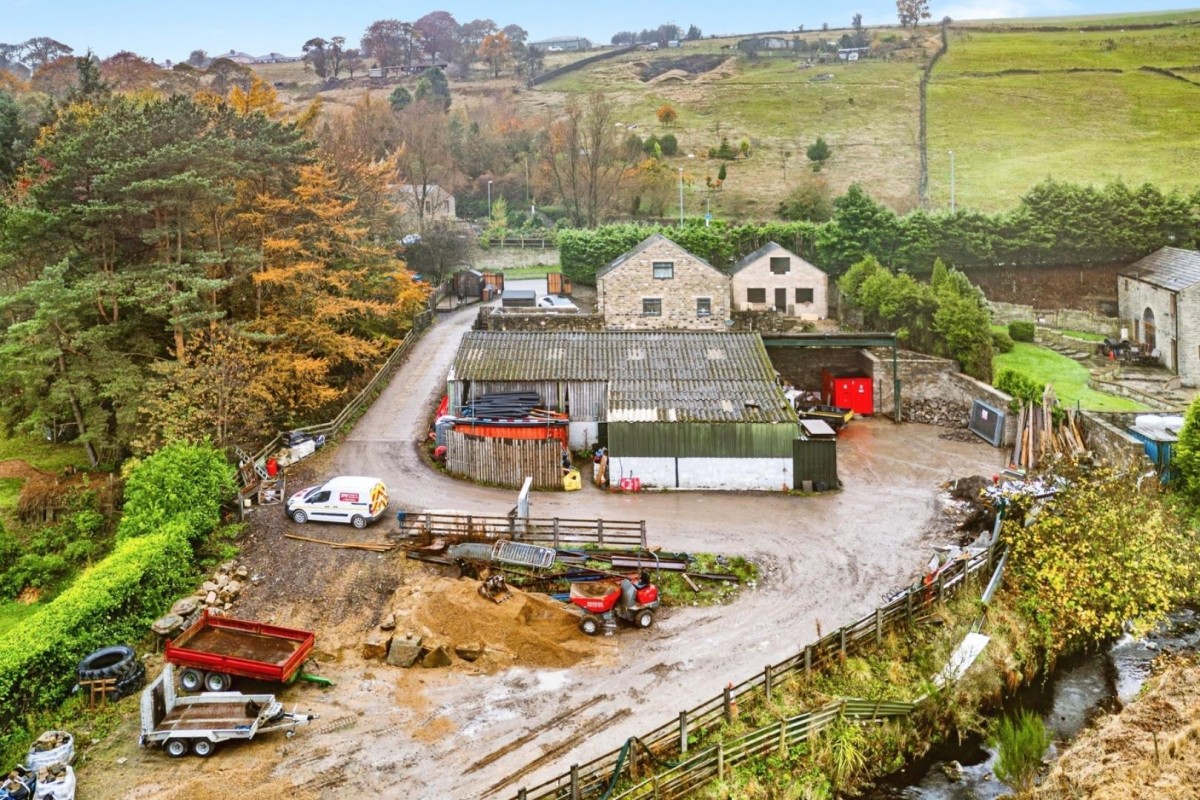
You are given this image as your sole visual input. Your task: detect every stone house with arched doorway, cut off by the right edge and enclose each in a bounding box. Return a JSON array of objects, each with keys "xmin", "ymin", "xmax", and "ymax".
[{"xmin": 1117, "ymin": 247, "xmax": 1200, "ymax": 386}]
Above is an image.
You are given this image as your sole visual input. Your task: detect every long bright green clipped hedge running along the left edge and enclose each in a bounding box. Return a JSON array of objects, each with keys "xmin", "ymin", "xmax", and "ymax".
[{"xmin": 0, "ymin": 521, "xmax": 193, "ymax": 741}]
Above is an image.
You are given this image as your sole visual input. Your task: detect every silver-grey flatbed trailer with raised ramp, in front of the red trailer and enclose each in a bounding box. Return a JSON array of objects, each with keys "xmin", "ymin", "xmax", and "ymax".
[{"xmin": 138, "ymin": 664, "xmax": 317, "ymax": 758}]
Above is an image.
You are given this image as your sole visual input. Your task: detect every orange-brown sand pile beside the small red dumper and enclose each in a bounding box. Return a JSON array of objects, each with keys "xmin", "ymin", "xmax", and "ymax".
[{"xmin": 397, "ymin": 578, "xmax": 604, "ymax": 669}]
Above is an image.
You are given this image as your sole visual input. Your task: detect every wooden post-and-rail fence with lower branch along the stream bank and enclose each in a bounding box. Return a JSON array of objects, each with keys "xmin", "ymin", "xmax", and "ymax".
[{"xmin": 504, "ymin": 519, "xmax": 1003, "ymax": 800}]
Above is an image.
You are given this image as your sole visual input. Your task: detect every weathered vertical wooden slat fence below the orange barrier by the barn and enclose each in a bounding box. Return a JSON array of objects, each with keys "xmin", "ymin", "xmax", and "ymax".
[{"xmin": 446, "ymin": 431, "xmax": 563, "ymax": 489}]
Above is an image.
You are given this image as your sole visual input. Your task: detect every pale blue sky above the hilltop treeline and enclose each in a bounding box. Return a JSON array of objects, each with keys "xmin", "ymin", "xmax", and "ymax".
[{"xmin": 0, "ymin": 0, "xmax": 1198, "ymax": 61}]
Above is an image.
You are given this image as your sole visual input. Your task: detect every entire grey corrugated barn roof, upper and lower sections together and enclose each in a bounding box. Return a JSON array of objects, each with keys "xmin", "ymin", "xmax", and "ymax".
[{"xmin": 452, "ymin": 331, "xmax": 797, "ymax": 423}]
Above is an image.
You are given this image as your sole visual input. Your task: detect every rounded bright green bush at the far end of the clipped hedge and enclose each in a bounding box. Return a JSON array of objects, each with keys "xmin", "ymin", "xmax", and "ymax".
[{"xmin": 116, "ymin": 443, "xmax": 234, "ymax": 542}]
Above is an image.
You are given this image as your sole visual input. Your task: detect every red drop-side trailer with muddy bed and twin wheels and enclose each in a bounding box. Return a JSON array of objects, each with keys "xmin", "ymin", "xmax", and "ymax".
[{"xmin": 163, "ymin": 610, "xmax": 316, "ymax": 692}]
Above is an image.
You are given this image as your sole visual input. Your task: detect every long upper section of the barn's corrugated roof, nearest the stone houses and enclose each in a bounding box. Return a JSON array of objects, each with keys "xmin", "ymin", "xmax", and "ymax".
[{"xmin": 454, "ymin": 331, "xmax": 775, "ymax": 385}]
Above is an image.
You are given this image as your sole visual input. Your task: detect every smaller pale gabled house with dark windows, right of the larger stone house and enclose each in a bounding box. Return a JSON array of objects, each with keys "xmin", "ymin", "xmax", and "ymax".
[{"xmin": 730, "ymin": 242, "xmax": 829, "ymax": 319}]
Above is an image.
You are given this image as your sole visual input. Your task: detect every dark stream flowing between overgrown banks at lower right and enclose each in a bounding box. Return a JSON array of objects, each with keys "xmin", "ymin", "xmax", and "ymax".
[{"xmin": 863, "ymin": 608, "xmax": 1200, "ymax": 800}]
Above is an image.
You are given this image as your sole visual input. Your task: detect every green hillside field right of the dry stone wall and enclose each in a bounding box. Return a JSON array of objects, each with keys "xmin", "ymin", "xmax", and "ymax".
[{"xmin": 929, "ymin": 25, "xmax": 1200, "ymax": 211}]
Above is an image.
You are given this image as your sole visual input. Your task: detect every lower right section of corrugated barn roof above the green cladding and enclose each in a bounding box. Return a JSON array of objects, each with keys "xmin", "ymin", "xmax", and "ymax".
[{"xmin": 607, "ymin": 380, "xmax": 797, "ymax": 425}]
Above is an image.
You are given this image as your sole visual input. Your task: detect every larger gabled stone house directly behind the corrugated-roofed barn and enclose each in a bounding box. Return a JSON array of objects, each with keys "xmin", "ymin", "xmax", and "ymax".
[{"xmin": 596, "ymin": 234, "xmax": 730, "ymax": 331}]
